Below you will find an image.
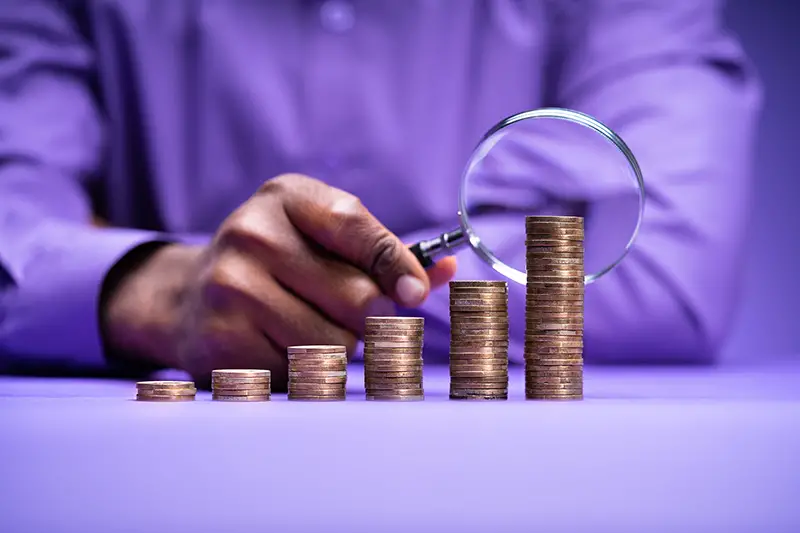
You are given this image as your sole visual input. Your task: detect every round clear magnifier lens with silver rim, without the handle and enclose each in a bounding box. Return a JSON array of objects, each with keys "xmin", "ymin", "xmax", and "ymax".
[{"xmin": 459, "ymin": 109, "xmax": 644, "ymax": 284}]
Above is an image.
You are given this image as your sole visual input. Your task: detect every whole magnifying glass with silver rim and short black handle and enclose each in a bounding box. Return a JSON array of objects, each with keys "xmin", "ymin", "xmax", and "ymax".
[{"xmin": 410, "ymin": 108, "xmax": 645, "ymax": 285}]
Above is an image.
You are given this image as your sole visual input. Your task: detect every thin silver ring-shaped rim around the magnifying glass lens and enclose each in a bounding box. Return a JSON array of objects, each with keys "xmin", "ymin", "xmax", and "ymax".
[{"xmin": 458, "ymin": 107, "xmax": 646, "ymax": 285}]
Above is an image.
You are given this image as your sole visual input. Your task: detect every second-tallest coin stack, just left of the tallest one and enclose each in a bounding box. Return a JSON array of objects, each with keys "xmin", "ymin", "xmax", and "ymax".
[{"xmin": 450, "ymin": 281, "xmax": 508, "ymax": 400}]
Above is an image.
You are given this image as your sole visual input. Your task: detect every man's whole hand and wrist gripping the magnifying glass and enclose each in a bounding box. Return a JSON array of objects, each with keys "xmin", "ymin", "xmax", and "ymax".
[{"xmin": 101, "ymin": 175, "xmax": 455, "ymax": 387}]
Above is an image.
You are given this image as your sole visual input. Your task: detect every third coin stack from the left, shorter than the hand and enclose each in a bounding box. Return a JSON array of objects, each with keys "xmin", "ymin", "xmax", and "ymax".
[{"xmin": 287, "ymin": 344, "xmax": 347, "ymax": 401}]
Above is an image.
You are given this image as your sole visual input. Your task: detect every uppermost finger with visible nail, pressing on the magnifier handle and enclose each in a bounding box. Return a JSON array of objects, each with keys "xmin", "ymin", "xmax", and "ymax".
[{"xmin": 261, "ymin": 175, "xmax": 430, "ymax": 307}]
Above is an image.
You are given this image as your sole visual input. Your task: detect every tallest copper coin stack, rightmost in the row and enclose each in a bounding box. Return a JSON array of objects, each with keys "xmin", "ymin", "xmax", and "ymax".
[{"xmin": 525, "ymin": 216, "xmax": 584, "ymax": 400}]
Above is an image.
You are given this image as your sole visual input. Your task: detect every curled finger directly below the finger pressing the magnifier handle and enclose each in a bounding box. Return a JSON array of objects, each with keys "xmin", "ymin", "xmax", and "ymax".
[{"xmin": 218, "ymin": 197, "xmax": 393, "ymax": 335}]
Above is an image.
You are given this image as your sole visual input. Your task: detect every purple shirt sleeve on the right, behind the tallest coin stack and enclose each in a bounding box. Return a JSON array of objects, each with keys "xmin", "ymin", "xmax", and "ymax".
[{"xmin": 406, "ymin": 0, "xmax": 761, "ymax": 362}]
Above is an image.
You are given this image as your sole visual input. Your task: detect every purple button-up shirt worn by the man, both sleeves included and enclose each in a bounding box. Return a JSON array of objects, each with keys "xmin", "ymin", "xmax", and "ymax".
[{"xmin": 0, "ymin": 0, "xmax": 760, "ymax": 367}]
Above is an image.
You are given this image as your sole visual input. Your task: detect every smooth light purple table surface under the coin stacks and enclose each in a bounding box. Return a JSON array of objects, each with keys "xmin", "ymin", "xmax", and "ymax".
[{"xmin": 0, "ymin": 361, "xmax": 800, "ymax": 533}]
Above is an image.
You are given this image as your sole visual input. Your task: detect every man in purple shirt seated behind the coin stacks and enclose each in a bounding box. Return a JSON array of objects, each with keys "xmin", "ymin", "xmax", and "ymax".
[{"xmin": 0, "ymin": 0, "xmax": 759, "ymax": 379}]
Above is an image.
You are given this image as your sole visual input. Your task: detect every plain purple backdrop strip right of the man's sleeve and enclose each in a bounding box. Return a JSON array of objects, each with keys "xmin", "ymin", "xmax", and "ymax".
[{"xmin": 724, "ymin": 0, "xmax": 800, "ymax": 360}]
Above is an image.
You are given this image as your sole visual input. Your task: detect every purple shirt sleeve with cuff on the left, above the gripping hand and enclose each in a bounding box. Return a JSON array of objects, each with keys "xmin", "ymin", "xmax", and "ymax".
[{"xmin": 0, "ymin": 0, "xmax": 162, "ymax": 368}]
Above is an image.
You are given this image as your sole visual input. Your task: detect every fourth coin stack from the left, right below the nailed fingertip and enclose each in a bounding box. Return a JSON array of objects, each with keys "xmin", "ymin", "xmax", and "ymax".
[{"xmin": 364, "ymin": 316, "xmax": 425, "ymax": 400}]
